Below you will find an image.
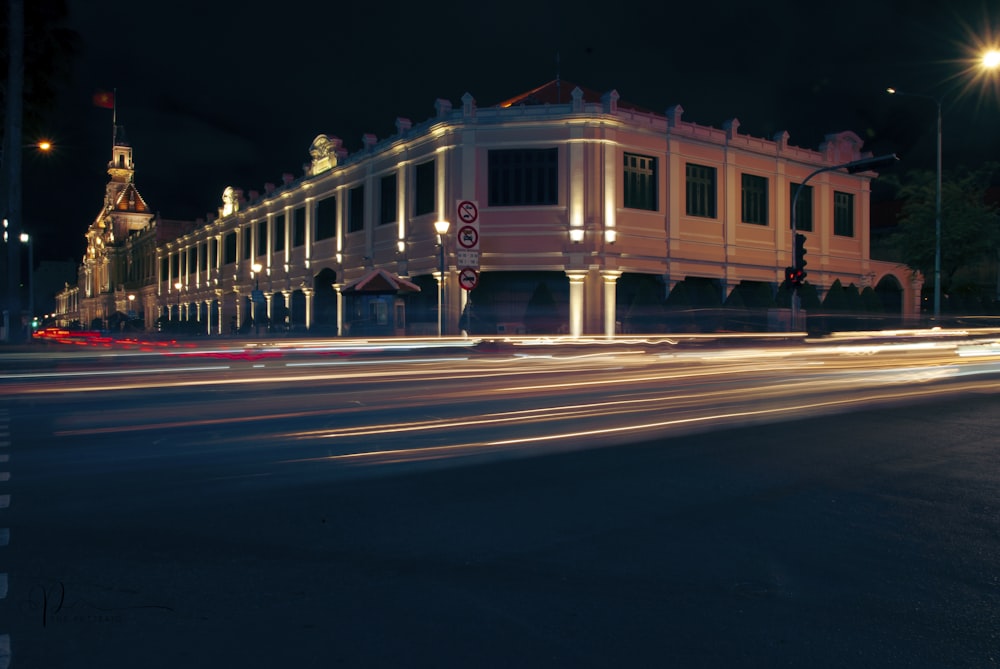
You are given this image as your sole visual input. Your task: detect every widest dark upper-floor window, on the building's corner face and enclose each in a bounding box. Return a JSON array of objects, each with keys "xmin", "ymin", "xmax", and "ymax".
[{"xmin": 487, "ymin": 149, "xmax": 559, "ymax": 207}]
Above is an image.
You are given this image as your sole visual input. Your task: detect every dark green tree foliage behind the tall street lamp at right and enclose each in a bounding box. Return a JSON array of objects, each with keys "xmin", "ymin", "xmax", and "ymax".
[{"xmin": 886, "ymin": 163, "xmax": 1000, "ymax": 292}]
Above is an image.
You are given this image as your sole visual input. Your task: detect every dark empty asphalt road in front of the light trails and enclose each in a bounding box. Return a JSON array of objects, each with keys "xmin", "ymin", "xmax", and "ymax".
[{"xmin": 0, "ymin": 342, "xmax": 1000, "ymax": 668}]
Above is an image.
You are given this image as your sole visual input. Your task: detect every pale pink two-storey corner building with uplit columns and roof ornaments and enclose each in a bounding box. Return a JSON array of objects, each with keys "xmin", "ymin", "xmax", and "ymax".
[{"xmin": 62, "ymin": 81, "xmax": 921, "ymax": 335}]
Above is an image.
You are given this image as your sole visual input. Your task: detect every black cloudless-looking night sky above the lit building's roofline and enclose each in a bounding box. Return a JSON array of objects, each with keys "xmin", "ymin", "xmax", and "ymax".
[{"xmin": 24, "ymin": 0, "xmax": 1000, "ymax": 260}]
